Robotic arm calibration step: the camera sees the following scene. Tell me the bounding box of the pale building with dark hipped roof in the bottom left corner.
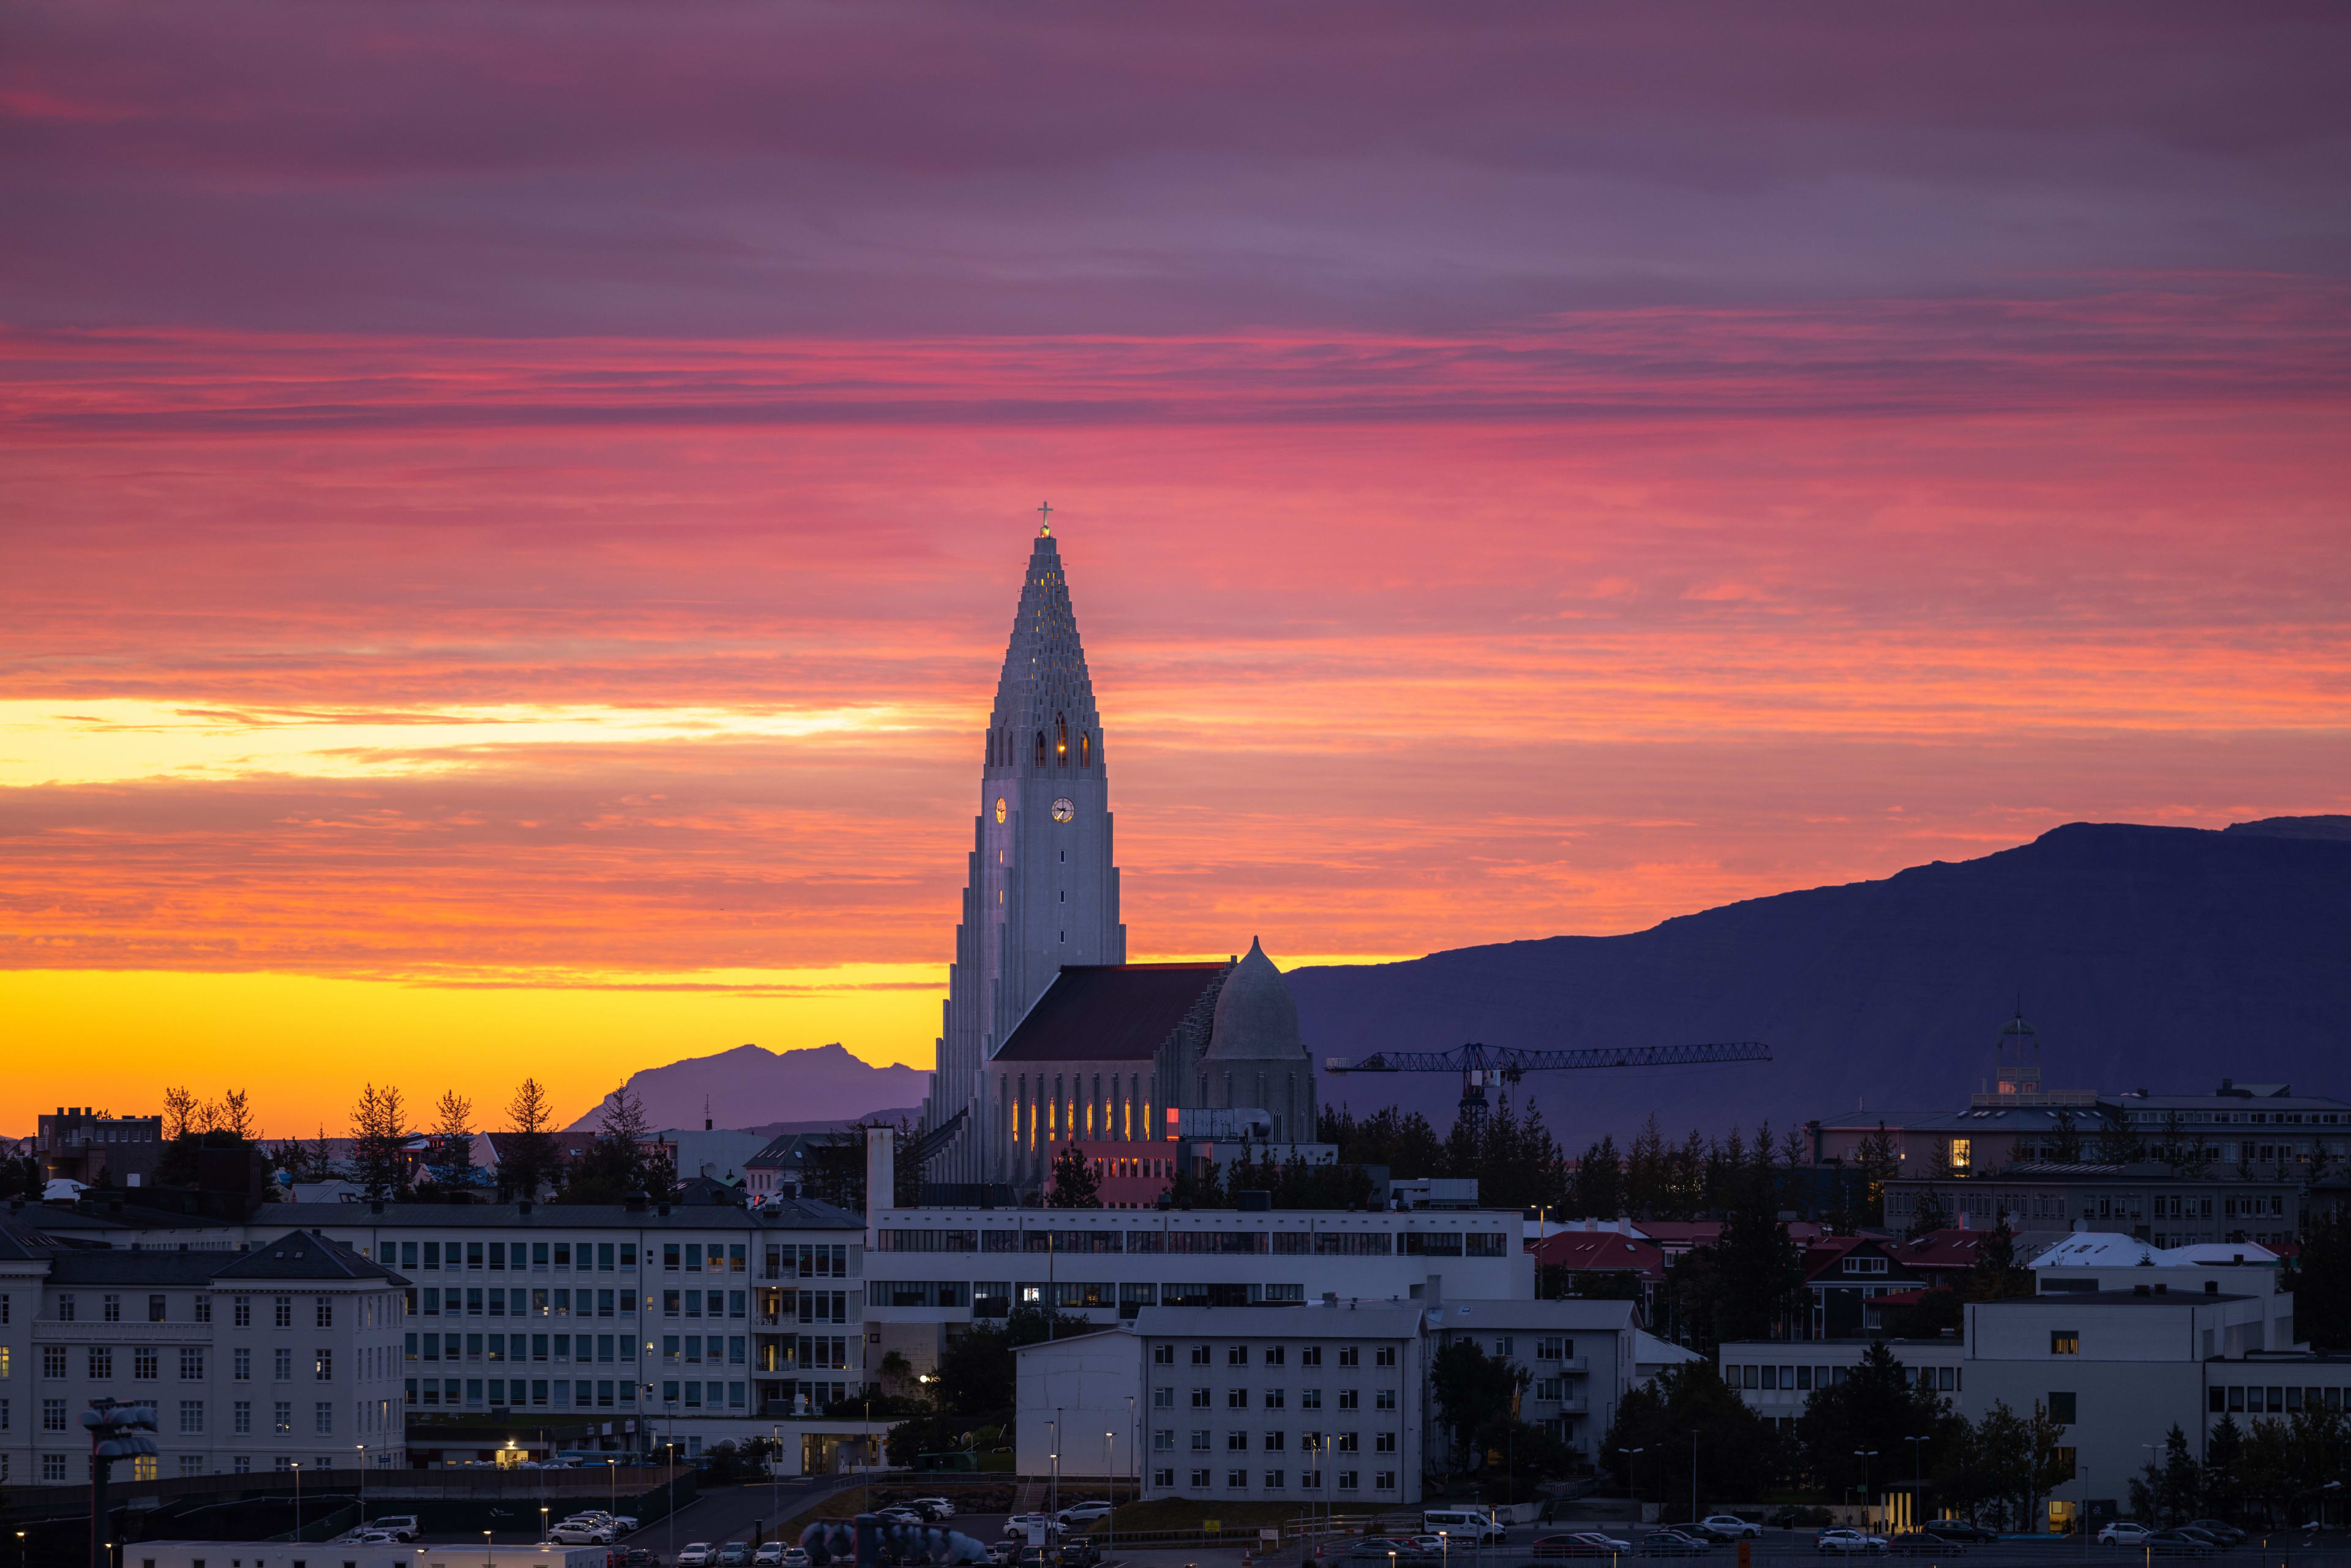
[0,1215,407,1486]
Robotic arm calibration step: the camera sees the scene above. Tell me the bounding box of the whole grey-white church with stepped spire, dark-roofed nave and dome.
[921,527,1316,1201]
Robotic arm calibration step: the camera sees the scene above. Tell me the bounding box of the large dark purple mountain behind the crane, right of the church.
[1291,816,2351,1154]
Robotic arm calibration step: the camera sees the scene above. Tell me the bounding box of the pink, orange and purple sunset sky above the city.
[0,0,2351,1133]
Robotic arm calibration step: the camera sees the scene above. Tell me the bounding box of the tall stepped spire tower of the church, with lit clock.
[921,524,1126,1182]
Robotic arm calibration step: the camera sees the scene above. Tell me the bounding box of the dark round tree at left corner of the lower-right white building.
[1601,1361,1785,1521]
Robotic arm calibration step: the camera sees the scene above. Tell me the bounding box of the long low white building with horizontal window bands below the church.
[863,1213,1535,1373]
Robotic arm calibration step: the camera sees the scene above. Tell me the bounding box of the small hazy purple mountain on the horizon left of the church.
[571,1044,931,1131]
